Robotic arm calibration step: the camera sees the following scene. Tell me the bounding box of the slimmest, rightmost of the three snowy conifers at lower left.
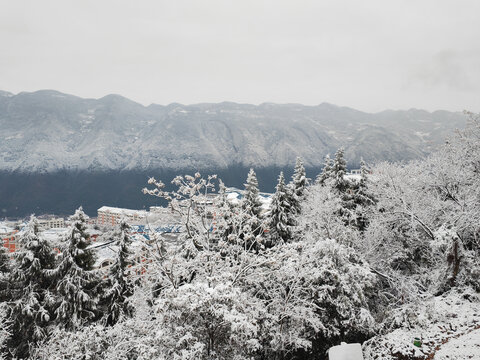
[105,219,134,325]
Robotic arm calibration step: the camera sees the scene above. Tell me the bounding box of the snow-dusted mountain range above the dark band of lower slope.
[0,90,465,173]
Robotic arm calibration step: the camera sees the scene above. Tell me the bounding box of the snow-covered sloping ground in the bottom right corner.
[363,291,480,360]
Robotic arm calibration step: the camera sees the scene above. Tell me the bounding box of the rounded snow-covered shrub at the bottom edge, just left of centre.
[155,281,262,359]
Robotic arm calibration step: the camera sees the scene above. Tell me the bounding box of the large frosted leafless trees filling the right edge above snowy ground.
[360,117,480,302]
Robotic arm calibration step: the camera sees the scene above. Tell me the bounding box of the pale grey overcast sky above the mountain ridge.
[0,0,480,112]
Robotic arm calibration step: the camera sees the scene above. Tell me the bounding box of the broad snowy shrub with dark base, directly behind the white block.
[242,239,377,358]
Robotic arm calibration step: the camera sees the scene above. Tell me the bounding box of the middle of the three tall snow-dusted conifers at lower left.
[52,207,101,329]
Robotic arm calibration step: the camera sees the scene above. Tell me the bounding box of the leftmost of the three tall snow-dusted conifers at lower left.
[8,216,56,359]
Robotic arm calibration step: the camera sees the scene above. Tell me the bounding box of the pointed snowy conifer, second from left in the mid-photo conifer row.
[268,172,295,245]
